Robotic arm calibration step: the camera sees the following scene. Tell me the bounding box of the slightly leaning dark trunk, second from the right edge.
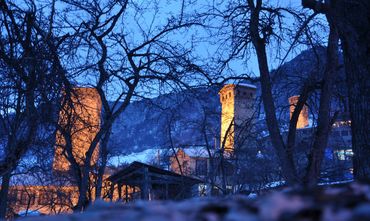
[305,25,339,186]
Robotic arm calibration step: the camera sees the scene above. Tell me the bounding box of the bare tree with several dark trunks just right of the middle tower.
[205,0,338,185]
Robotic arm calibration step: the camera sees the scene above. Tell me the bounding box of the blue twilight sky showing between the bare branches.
[28,0,327,99]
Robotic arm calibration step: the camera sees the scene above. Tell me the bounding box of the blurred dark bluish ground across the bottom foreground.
[24,183,370,221]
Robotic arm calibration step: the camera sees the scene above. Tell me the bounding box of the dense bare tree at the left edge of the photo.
[0,1,66,218]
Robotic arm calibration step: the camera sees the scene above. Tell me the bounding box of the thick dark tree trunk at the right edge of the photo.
[302,0,370,180]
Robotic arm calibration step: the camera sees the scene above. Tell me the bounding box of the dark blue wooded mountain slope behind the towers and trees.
[109,47,345,153]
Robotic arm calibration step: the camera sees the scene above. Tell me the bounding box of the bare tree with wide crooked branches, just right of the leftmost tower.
[48,0,211,210]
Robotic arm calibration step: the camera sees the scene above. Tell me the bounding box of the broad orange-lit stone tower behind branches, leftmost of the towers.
[53,88,102,171]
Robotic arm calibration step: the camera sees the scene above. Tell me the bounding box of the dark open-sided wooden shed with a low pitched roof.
[107,161,203,202]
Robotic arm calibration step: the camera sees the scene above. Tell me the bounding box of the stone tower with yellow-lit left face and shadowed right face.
[219,84,257,152]
